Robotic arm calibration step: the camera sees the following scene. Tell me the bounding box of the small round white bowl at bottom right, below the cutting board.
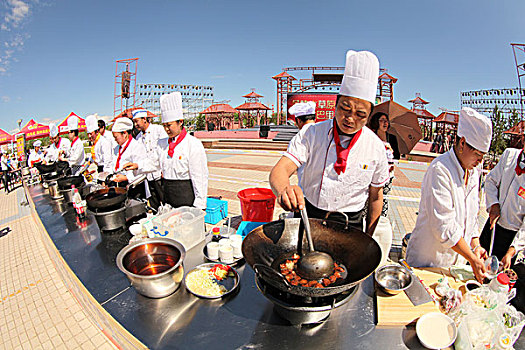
[416,312,458,349]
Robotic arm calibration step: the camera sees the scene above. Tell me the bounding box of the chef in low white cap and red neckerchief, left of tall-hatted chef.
[108,117,155,198]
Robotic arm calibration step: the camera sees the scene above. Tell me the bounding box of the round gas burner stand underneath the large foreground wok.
[255,275,358,325]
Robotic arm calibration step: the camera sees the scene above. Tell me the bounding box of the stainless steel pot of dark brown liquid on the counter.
[117,238,186,298]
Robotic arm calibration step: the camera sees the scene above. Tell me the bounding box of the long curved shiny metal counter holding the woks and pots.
[27,185,492,349]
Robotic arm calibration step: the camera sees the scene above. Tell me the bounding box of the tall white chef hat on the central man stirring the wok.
[339,50,379,104]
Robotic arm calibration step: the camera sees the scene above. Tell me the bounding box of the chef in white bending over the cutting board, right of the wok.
[407,108,492,281]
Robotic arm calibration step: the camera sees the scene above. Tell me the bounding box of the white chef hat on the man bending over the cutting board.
[458,107,492,152]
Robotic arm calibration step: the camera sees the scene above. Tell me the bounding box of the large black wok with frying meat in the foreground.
[242,219,381,297]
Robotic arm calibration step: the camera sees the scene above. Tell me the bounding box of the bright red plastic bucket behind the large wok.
[237,188,276,222]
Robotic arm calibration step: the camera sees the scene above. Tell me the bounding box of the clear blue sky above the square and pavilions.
[0,0,525,132]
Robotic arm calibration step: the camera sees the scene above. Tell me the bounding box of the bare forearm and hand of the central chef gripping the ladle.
[270,156,304,211]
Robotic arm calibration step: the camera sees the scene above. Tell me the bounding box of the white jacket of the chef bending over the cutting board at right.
[407,149,480,267]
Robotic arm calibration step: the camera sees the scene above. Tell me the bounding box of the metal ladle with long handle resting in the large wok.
[297,208,334,280]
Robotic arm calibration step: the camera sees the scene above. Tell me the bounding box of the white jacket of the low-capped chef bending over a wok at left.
[104,138,156,183]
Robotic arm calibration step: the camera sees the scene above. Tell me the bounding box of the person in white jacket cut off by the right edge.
[480,141,525,268]
